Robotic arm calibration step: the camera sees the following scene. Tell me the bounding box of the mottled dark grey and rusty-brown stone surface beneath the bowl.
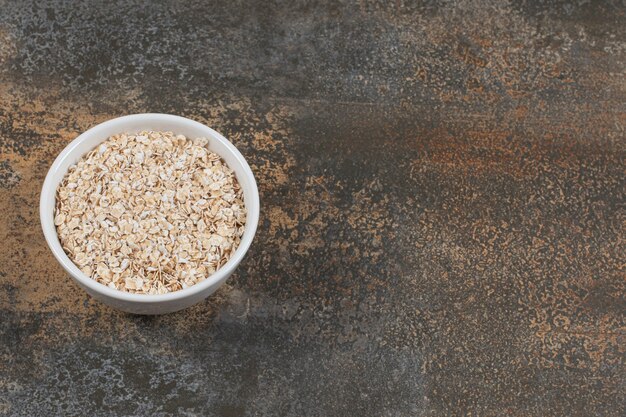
[0,0,626,417]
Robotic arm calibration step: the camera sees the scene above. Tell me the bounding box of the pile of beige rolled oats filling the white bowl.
[54,131,246,294]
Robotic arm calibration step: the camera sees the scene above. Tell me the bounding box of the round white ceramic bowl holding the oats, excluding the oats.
[39,114,259,314]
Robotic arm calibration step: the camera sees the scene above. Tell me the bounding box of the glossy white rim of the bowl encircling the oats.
[39,113,260,303]
